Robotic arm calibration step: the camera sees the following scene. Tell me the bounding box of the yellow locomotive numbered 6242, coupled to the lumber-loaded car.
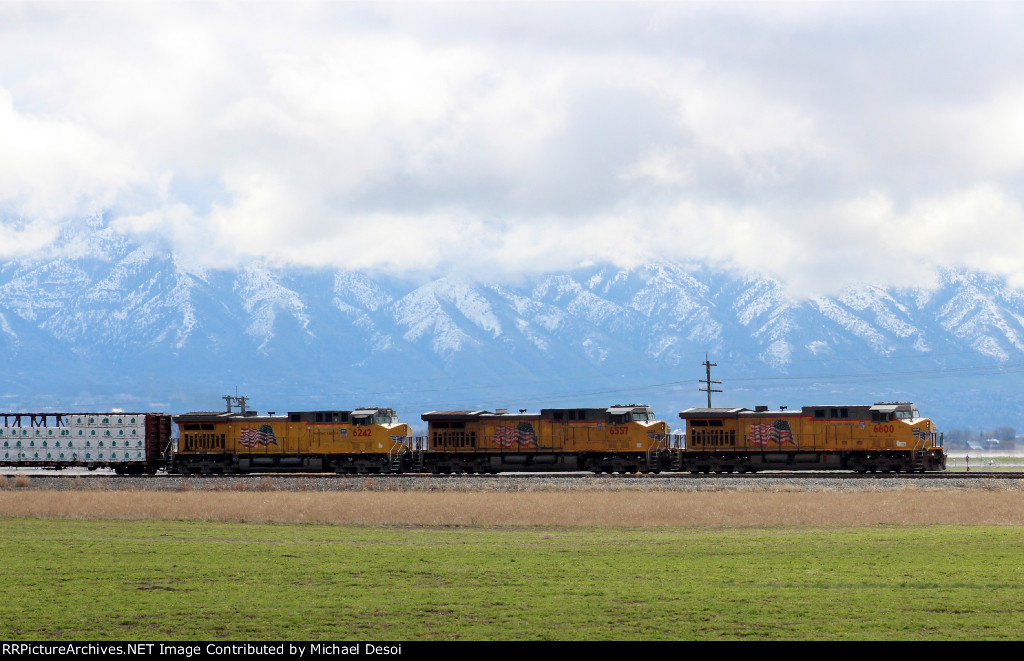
[171,397,413,473]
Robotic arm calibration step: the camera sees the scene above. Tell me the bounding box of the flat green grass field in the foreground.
[0,519,1024,641]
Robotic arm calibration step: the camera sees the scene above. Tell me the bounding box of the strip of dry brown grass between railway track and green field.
[0,489,1024,526]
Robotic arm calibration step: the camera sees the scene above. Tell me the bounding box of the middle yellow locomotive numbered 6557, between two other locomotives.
[412,404,671,473]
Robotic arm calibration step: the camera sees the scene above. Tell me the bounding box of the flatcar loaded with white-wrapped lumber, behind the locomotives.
[0,411,172,475]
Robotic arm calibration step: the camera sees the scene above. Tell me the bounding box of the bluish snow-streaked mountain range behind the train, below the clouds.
[0,228,1024,429]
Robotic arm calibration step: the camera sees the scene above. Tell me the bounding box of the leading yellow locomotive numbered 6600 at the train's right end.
[679,402,946,473]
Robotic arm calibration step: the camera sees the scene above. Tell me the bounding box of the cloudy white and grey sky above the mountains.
[0,0,1024,295]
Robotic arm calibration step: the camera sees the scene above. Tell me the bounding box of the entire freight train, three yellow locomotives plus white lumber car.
[0,397,946,474]
